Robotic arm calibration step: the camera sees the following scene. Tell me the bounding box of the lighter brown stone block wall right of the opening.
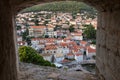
[96,10,120,80]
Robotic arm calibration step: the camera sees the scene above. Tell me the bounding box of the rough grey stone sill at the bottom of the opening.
[19,63,97,80]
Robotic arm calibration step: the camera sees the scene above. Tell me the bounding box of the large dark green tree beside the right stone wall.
[83,24,96,39]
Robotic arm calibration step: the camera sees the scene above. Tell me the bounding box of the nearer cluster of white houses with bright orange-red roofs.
[31,38,96,63]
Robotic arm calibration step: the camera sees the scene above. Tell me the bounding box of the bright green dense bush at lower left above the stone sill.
[19,46,55,67]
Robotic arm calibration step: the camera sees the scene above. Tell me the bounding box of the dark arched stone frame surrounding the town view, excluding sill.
[0,0,120,80]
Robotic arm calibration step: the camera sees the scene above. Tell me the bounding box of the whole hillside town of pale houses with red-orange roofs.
[16,11,97,63]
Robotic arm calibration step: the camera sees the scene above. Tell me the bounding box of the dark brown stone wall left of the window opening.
[0,0,17,80]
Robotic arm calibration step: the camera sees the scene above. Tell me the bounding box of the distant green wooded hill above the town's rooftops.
[21,1,96,13]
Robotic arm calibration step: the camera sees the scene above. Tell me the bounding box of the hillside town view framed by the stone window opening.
[16,1,97,80]
